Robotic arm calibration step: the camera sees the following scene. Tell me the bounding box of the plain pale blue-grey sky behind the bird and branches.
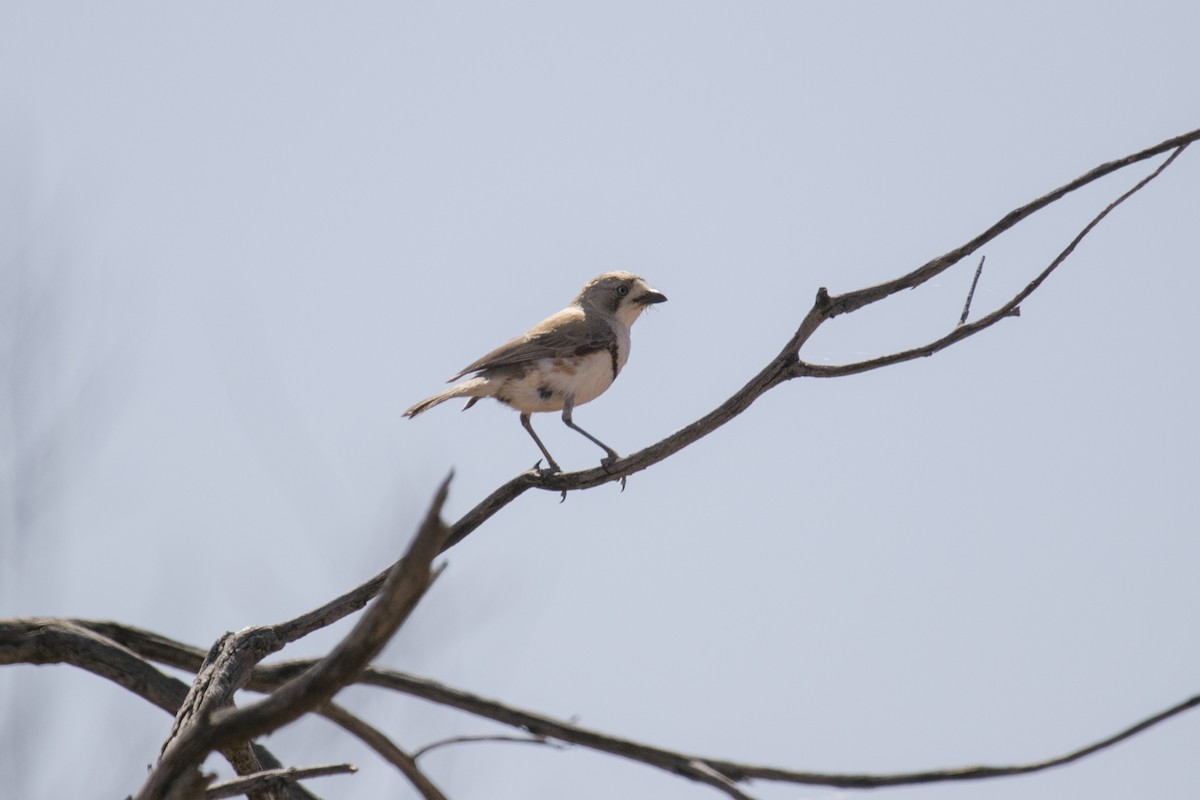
[0,1,1200,800]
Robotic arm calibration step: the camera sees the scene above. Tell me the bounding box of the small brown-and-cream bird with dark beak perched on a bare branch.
[404,272,666,474]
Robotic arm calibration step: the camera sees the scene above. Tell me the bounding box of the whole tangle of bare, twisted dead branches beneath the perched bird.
[0,130,1200,800]
